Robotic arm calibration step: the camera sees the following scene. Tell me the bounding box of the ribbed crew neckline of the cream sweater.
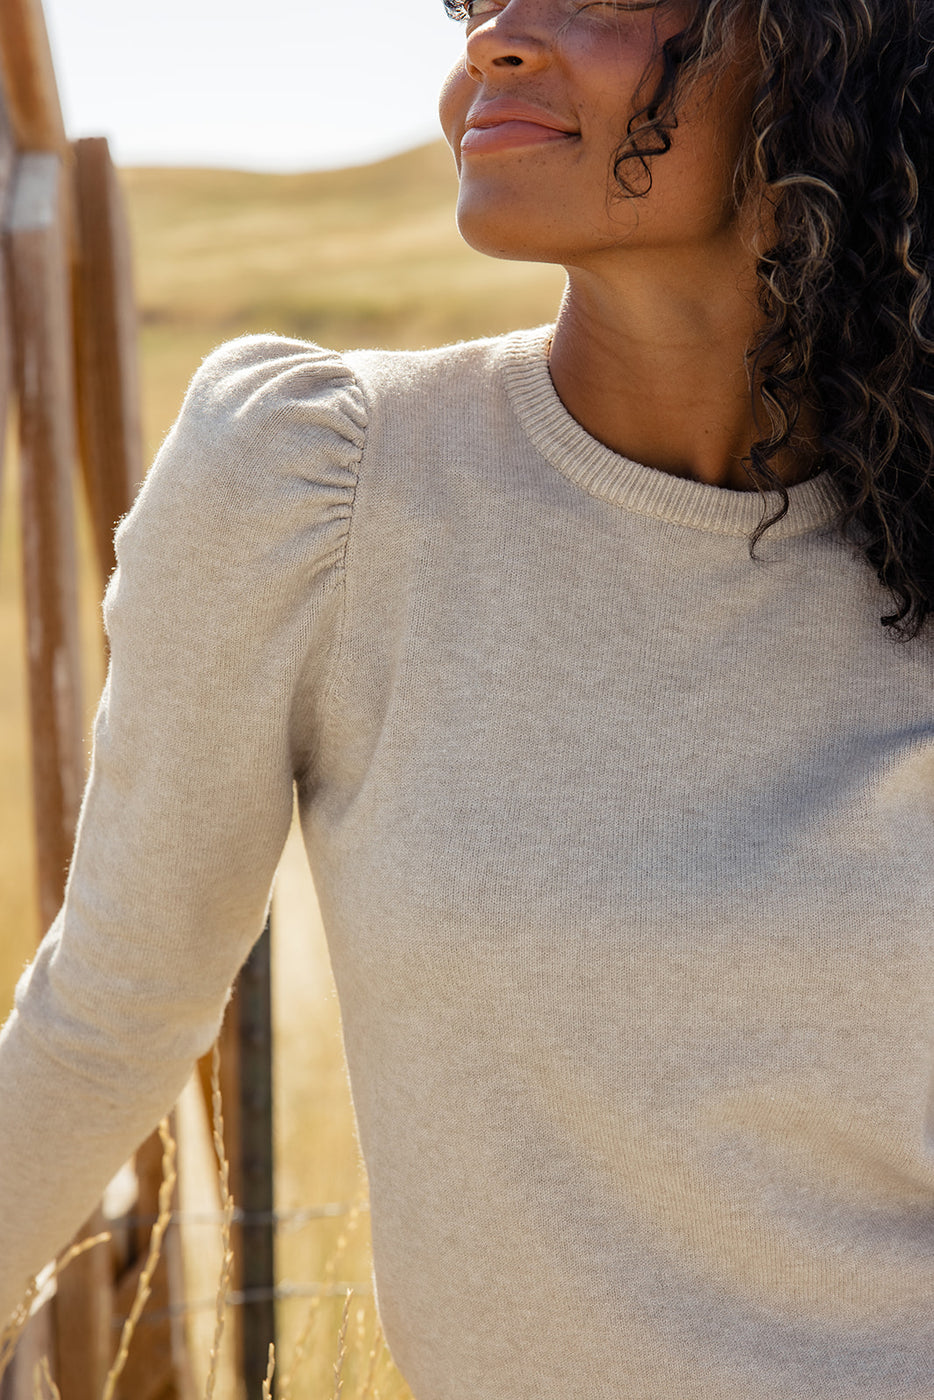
[503,326,840,538]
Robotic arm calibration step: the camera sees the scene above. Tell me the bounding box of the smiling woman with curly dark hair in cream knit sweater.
[0,0,934,1400]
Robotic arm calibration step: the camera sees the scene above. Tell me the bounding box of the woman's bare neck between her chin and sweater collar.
[550,251,808,490]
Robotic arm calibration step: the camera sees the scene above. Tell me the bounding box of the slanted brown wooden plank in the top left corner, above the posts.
[0,0,67,155]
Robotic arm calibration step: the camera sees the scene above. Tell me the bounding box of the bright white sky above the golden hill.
[43,0,462,171]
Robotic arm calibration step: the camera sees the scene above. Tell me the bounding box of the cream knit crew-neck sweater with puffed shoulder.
[0,332,934,1400]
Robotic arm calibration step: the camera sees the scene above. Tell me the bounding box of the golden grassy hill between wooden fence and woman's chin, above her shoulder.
[122,141,564,445]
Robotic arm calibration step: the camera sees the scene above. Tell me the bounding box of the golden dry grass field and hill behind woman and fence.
[0,144,563,1400]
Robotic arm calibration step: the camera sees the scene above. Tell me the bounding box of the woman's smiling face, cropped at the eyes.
[440,0,748,266]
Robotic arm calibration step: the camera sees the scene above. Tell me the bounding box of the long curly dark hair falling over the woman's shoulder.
[444,0,934,640]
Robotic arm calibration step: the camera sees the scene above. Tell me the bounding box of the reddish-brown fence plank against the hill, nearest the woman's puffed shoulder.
[73,137,143,581]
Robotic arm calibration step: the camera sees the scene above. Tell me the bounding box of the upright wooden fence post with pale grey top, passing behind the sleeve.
[0,147,111,1400]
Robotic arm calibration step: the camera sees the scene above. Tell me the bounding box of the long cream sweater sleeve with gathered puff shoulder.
[0,336,365,1323]
